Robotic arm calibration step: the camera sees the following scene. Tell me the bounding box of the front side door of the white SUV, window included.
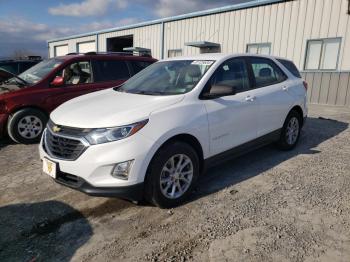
[203,57,258,156]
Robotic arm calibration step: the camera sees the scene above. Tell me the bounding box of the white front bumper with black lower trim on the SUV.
[39,132,156,201]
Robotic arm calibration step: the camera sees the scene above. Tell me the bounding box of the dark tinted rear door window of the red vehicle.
[92,60,130,82]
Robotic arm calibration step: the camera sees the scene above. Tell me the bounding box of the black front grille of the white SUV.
[44,128,88,160]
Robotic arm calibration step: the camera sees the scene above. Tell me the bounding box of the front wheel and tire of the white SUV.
[145,142,199,208]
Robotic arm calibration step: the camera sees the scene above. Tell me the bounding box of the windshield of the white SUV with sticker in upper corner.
[117,60,214,95]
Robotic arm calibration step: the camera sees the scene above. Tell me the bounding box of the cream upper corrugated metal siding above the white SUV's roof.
[160,0,350,70]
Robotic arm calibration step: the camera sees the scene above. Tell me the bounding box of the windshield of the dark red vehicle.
[18,58,63,85]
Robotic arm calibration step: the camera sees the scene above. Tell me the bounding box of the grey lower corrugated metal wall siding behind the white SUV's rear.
[302,72,350,106]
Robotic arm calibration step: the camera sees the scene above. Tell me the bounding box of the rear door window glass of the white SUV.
[249,57,287,87]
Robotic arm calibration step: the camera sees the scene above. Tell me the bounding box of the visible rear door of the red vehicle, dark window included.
[92,59,131,90]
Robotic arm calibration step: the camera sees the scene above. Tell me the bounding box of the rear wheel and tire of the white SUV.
[277,110,302,150]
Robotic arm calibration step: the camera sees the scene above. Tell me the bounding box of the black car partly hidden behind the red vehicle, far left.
[0,56,42,83]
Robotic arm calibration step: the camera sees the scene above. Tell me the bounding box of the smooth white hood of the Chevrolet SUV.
[50,89,184,128]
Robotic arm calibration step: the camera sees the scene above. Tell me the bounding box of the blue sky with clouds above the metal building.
[0,0,249,57]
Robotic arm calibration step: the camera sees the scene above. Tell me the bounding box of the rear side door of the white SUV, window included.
[248,57,293,137]
